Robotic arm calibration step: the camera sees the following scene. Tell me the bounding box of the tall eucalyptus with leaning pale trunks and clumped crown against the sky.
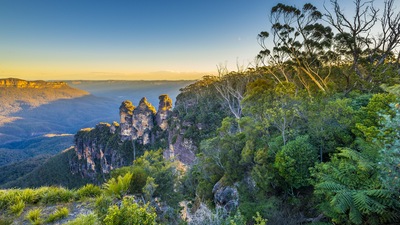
[258,3,333,95]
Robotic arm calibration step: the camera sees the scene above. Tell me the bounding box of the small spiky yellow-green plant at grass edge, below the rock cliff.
[103,173,132,199]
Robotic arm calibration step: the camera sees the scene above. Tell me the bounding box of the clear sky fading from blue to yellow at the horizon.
[0,0,396,80]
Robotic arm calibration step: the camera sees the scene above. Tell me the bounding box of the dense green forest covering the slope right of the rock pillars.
[0,0,400,225]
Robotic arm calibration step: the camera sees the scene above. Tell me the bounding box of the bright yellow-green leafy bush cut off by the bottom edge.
[103,198,157,225]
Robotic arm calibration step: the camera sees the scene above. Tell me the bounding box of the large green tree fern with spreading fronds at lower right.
[315,149,399,224]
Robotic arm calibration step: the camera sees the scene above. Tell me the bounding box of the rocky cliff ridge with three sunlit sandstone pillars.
[70,95,196,183]
